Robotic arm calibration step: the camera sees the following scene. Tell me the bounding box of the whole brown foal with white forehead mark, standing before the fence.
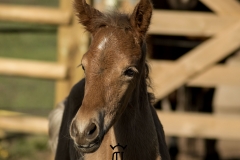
[50,0,170,160]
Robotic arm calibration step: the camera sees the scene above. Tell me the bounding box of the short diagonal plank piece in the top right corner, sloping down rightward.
[200,0,240,17]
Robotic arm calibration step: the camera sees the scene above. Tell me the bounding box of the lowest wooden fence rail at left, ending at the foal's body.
[0,111,48,135]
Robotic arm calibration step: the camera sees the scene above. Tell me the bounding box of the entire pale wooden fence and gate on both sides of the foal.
[0,0,240,144]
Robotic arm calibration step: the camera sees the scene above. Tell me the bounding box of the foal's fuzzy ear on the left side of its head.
[74,0,103,33]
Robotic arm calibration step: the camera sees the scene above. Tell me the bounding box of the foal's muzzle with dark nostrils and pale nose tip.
[70,119,102,153]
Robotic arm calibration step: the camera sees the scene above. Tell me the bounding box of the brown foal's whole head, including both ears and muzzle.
[70,0,152,153]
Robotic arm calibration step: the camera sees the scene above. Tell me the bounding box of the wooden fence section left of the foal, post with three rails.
[0,0,88,134]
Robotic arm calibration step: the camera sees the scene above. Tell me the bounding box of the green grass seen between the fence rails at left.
[0,0,58,160]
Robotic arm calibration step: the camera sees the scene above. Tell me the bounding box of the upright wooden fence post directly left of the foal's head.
[55,0,89,104]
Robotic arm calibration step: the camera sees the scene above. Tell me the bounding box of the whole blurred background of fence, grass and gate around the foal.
[0,0,240,160]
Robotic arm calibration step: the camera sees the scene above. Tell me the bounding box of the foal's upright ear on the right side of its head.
[130,0,153,36]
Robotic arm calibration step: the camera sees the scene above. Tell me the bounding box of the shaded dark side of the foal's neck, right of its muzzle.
[111,76,158,160]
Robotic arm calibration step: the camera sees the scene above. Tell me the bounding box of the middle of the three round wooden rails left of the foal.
[0,58,67,79]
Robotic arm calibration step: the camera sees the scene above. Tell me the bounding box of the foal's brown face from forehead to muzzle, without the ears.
[71,27,142,152]
